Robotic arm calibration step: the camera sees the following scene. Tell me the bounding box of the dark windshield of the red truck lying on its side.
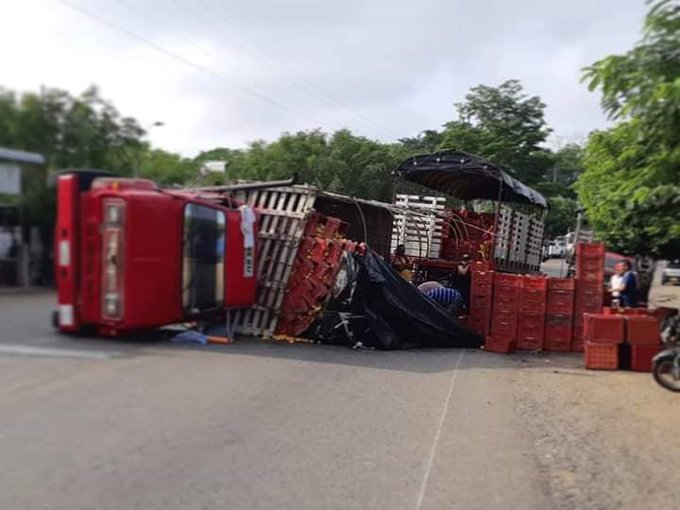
[182,203,226,315]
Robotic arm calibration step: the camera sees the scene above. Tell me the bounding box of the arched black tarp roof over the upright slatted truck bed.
[393,150,547,209]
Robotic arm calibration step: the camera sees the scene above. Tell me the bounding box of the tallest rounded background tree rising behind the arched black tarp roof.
[441,80,552,184]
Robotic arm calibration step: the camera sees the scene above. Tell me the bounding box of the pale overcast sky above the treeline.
[0,0,645,156]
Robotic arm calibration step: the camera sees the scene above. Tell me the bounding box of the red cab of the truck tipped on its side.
[55,172,256,335]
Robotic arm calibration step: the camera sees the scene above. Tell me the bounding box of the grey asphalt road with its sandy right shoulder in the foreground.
[0,294,680,510]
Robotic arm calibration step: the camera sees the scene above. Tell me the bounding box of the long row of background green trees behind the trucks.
[0,80,581,241]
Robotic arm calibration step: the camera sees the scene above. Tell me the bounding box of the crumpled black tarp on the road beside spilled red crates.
[305,250,483,350]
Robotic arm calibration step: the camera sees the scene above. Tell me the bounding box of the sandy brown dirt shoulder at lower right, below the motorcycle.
[515,354,680,510]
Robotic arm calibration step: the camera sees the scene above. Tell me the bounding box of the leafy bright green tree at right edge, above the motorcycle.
[577,0,680,257]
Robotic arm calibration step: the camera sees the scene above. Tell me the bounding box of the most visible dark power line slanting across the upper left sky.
[59,0,323,126]
